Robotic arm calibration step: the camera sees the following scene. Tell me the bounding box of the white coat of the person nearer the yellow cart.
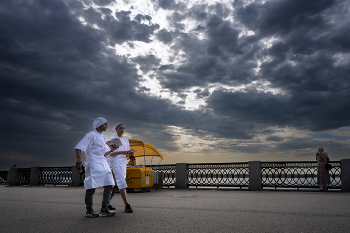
[107,135,130,189]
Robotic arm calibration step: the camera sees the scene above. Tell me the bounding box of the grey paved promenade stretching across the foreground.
[0,185,350,233]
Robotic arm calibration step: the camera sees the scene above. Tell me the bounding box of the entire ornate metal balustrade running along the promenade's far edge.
[0,159,350,190]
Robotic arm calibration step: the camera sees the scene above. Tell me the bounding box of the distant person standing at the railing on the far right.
[316,147,331,191]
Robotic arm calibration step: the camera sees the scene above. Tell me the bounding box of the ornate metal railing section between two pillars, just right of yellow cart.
[187,163,249,188]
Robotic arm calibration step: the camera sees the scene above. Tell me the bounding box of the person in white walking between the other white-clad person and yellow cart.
[107,123,134,213]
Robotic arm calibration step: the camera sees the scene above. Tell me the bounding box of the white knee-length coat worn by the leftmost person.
[75,130,115,189]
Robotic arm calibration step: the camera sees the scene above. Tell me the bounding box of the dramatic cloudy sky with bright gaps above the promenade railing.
[0,0,350,170]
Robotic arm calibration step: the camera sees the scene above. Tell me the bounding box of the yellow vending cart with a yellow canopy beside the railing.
[126,139,163,191]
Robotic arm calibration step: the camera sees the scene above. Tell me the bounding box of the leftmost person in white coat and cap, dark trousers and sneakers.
[75,117,117,218]
